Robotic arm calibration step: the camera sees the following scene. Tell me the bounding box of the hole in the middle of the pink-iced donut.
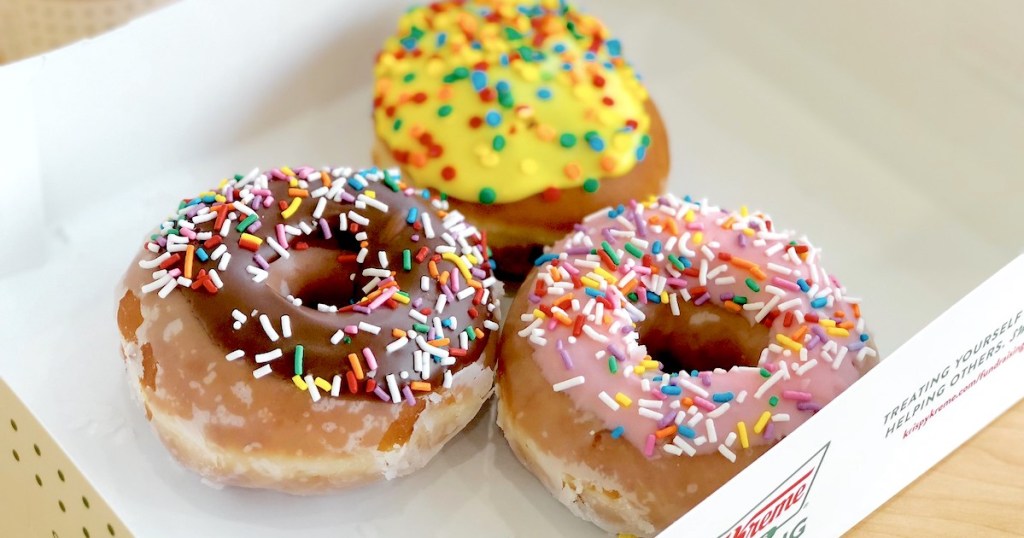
[638,303,768,373]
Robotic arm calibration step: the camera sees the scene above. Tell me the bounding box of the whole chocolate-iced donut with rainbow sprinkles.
[117,167,502,494]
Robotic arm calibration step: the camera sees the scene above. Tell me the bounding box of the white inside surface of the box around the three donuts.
[0,0,1024,537]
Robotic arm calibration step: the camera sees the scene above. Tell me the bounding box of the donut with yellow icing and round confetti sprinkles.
[373,0,669,282]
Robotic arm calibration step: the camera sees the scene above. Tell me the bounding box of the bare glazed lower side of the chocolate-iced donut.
[119,282,497,495]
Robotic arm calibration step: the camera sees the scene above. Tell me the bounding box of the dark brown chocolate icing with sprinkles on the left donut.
[137,169,498,399]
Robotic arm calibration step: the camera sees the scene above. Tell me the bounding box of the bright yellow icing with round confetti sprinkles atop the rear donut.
[374,0,650,203]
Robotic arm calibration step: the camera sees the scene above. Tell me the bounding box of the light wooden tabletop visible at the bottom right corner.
[848,401,1024,538]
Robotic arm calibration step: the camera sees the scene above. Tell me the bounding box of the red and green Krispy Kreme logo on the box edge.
[719,443,828,538]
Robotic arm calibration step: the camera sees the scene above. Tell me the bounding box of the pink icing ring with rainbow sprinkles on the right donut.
[519,195,877,459]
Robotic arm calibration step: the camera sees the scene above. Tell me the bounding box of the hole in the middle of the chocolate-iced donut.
[265,248,362,308]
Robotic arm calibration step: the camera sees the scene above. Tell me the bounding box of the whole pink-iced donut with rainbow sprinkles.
[497,195,878,536]
